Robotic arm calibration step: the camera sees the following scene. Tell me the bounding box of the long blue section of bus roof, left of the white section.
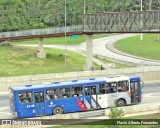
[10,78,106,91]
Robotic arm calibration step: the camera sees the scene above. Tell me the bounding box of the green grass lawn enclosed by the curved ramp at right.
[115,34,160,60]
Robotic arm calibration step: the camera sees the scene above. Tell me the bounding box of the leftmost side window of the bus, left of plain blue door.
[18,92,32,103]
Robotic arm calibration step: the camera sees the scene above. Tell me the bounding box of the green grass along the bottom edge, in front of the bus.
[50,114,160,128]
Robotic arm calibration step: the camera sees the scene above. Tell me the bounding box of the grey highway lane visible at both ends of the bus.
[0,83,160,119]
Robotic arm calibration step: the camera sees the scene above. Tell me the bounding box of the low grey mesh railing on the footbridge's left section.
[0,25,83,38]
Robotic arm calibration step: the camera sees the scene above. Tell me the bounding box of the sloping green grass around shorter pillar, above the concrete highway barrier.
[0,46,99,77]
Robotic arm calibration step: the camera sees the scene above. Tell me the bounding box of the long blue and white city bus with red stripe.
[9,75,142,118]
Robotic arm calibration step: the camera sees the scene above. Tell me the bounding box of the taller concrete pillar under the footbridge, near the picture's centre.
[83,35,93,71]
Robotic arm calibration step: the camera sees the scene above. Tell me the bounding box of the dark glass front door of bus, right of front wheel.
[130,81,139,104]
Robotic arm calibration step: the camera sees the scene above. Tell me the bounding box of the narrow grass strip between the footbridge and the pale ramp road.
[11,34,113,45]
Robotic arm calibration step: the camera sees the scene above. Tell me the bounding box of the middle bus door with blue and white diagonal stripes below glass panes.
[84,86,99,109]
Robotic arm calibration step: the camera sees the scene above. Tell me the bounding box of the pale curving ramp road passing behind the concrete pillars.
[21,34,160,66]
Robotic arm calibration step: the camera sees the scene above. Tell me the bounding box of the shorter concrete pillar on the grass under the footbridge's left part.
[36,38,46,58]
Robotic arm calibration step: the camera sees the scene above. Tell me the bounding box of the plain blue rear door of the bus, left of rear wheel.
[34,91,45,116]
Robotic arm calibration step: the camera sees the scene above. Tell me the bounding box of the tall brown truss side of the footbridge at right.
[84,11,160,33]
